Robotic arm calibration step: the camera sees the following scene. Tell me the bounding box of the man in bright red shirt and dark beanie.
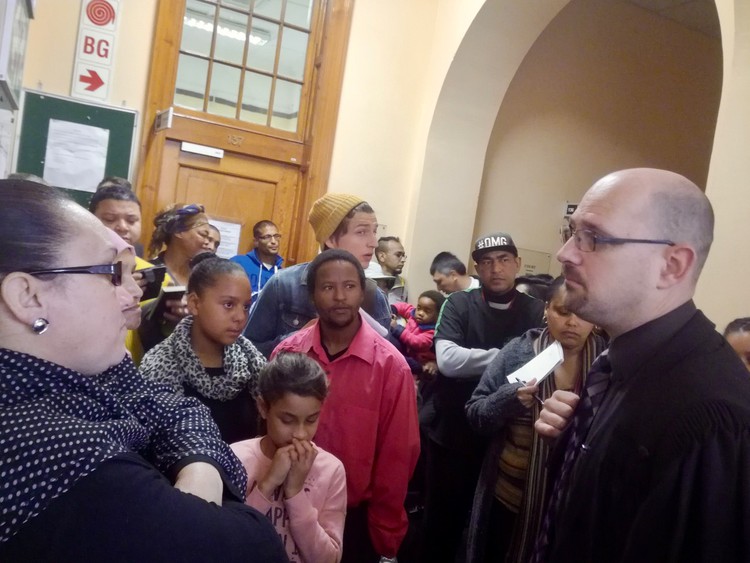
[274,250,419,563]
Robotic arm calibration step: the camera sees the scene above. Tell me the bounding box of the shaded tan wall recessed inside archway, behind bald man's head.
[474,0,722,275]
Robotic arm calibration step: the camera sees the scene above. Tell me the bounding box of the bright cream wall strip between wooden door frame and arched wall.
[329,0,435,236]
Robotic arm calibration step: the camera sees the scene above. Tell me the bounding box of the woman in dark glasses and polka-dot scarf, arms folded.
[0,181,286,562]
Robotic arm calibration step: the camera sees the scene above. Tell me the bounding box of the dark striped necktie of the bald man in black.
[531,350,612,563]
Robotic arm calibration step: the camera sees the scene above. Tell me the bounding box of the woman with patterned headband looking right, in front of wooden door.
[138,203,214,353]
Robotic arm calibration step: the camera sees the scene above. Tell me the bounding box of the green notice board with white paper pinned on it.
[16,91,136,207]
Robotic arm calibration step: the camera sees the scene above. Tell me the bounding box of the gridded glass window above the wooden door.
[174,0,317,132]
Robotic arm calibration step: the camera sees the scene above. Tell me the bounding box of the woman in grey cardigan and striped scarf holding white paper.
[466,277,604,563]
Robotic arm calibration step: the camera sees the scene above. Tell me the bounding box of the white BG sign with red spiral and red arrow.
[71,0,121,100]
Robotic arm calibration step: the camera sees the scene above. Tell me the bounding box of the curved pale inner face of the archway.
[406,0,568,295]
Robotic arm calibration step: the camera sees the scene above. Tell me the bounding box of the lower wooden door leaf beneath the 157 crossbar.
[144,140,306,265]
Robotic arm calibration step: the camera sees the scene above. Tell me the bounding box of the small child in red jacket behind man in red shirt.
[391,290,445,375]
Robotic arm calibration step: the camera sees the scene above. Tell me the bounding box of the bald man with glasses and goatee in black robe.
[532,169,750,562]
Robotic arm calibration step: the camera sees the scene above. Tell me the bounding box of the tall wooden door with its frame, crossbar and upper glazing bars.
[137,0,353,265]
